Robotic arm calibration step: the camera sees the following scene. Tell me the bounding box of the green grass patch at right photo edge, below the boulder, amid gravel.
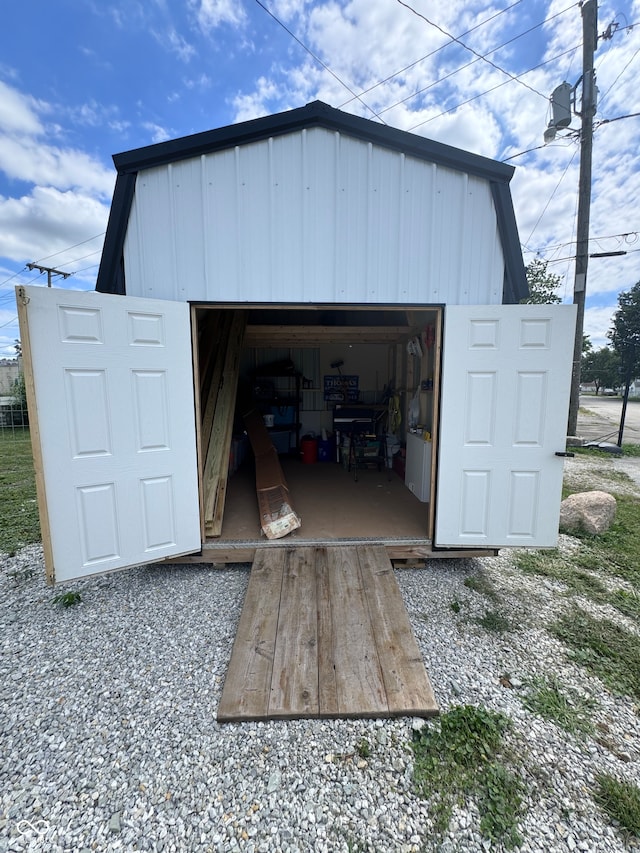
[550,609,640,699]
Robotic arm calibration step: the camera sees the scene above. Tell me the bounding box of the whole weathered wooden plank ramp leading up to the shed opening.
[218,546,438,722]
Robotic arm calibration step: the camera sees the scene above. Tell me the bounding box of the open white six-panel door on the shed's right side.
[434,305,575,548]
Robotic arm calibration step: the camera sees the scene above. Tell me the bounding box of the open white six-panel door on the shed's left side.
[18,287,201,581]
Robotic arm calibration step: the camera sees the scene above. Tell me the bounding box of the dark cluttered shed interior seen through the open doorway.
[192,304,442,562]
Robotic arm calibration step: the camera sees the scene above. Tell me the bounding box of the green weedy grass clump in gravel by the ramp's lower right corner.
[413,705,524,848]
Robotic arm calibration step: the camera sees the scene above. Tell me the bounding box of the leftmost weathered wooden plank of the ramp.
[218,549,285,722]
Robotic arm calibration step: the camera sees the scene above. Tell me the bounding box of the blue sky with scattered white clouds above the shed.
[0,0,640,357]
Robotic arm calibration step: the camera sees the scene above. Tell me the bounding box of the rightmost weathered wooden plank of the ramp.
[356,546,438,716]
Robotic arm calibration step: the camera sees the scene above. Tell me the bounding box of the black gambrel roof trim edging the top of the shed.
[96,101,528,303]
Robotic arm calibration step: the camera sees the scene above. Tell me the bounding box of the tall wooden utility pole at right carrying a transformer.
[567,0,598,435]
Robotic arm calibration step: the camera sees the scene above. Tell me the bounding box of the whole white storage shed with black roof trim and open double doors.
[18,102,575,581]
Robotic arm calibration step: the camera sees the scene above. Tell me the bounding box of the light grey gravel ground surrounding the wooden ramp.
[0,460,640,853]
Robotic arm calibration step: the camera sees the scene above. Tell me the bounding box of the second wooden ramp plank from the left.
[269,548,319,719]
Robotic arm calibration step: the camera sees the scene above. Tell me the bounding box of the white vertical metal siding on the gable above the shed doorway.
[125,123,504,304]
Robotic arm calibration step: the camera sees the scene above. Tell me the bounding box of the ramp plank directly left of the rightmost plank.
[321,548,388,716]
